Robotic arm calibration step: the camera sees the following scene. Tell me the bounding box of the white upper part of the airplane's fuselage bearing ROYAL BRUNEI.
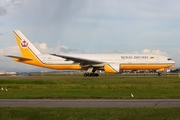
[38,54,175,64]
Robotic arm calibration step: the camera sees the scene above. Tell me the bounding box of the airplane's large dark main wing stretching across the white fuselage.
[51,54,103,65]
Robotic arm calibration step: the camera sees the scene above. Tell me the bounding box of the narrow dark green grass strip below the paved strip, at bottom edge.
[0,108,180,120]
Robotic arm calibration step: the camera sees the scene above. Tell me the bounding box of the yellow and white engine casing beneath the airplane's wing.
[104,63,120,73]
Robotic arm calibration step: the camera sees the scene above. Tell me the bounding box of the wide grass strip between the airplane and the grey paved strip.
[0,75,180,99]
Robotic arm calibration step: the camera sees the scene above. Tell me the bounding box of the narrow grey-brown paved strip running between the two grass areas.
[0,99,180,108]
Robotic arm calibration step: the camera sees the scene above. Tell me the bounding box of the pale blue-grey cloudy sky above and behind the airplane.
[0,0,180,71]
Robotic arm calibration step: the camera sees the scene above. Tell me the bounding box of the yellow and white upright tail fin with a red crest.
[14,30,41,58]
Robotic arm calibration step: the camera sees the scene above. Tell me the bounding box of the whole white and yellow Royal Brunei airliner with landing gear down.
[7,30,175,77]
